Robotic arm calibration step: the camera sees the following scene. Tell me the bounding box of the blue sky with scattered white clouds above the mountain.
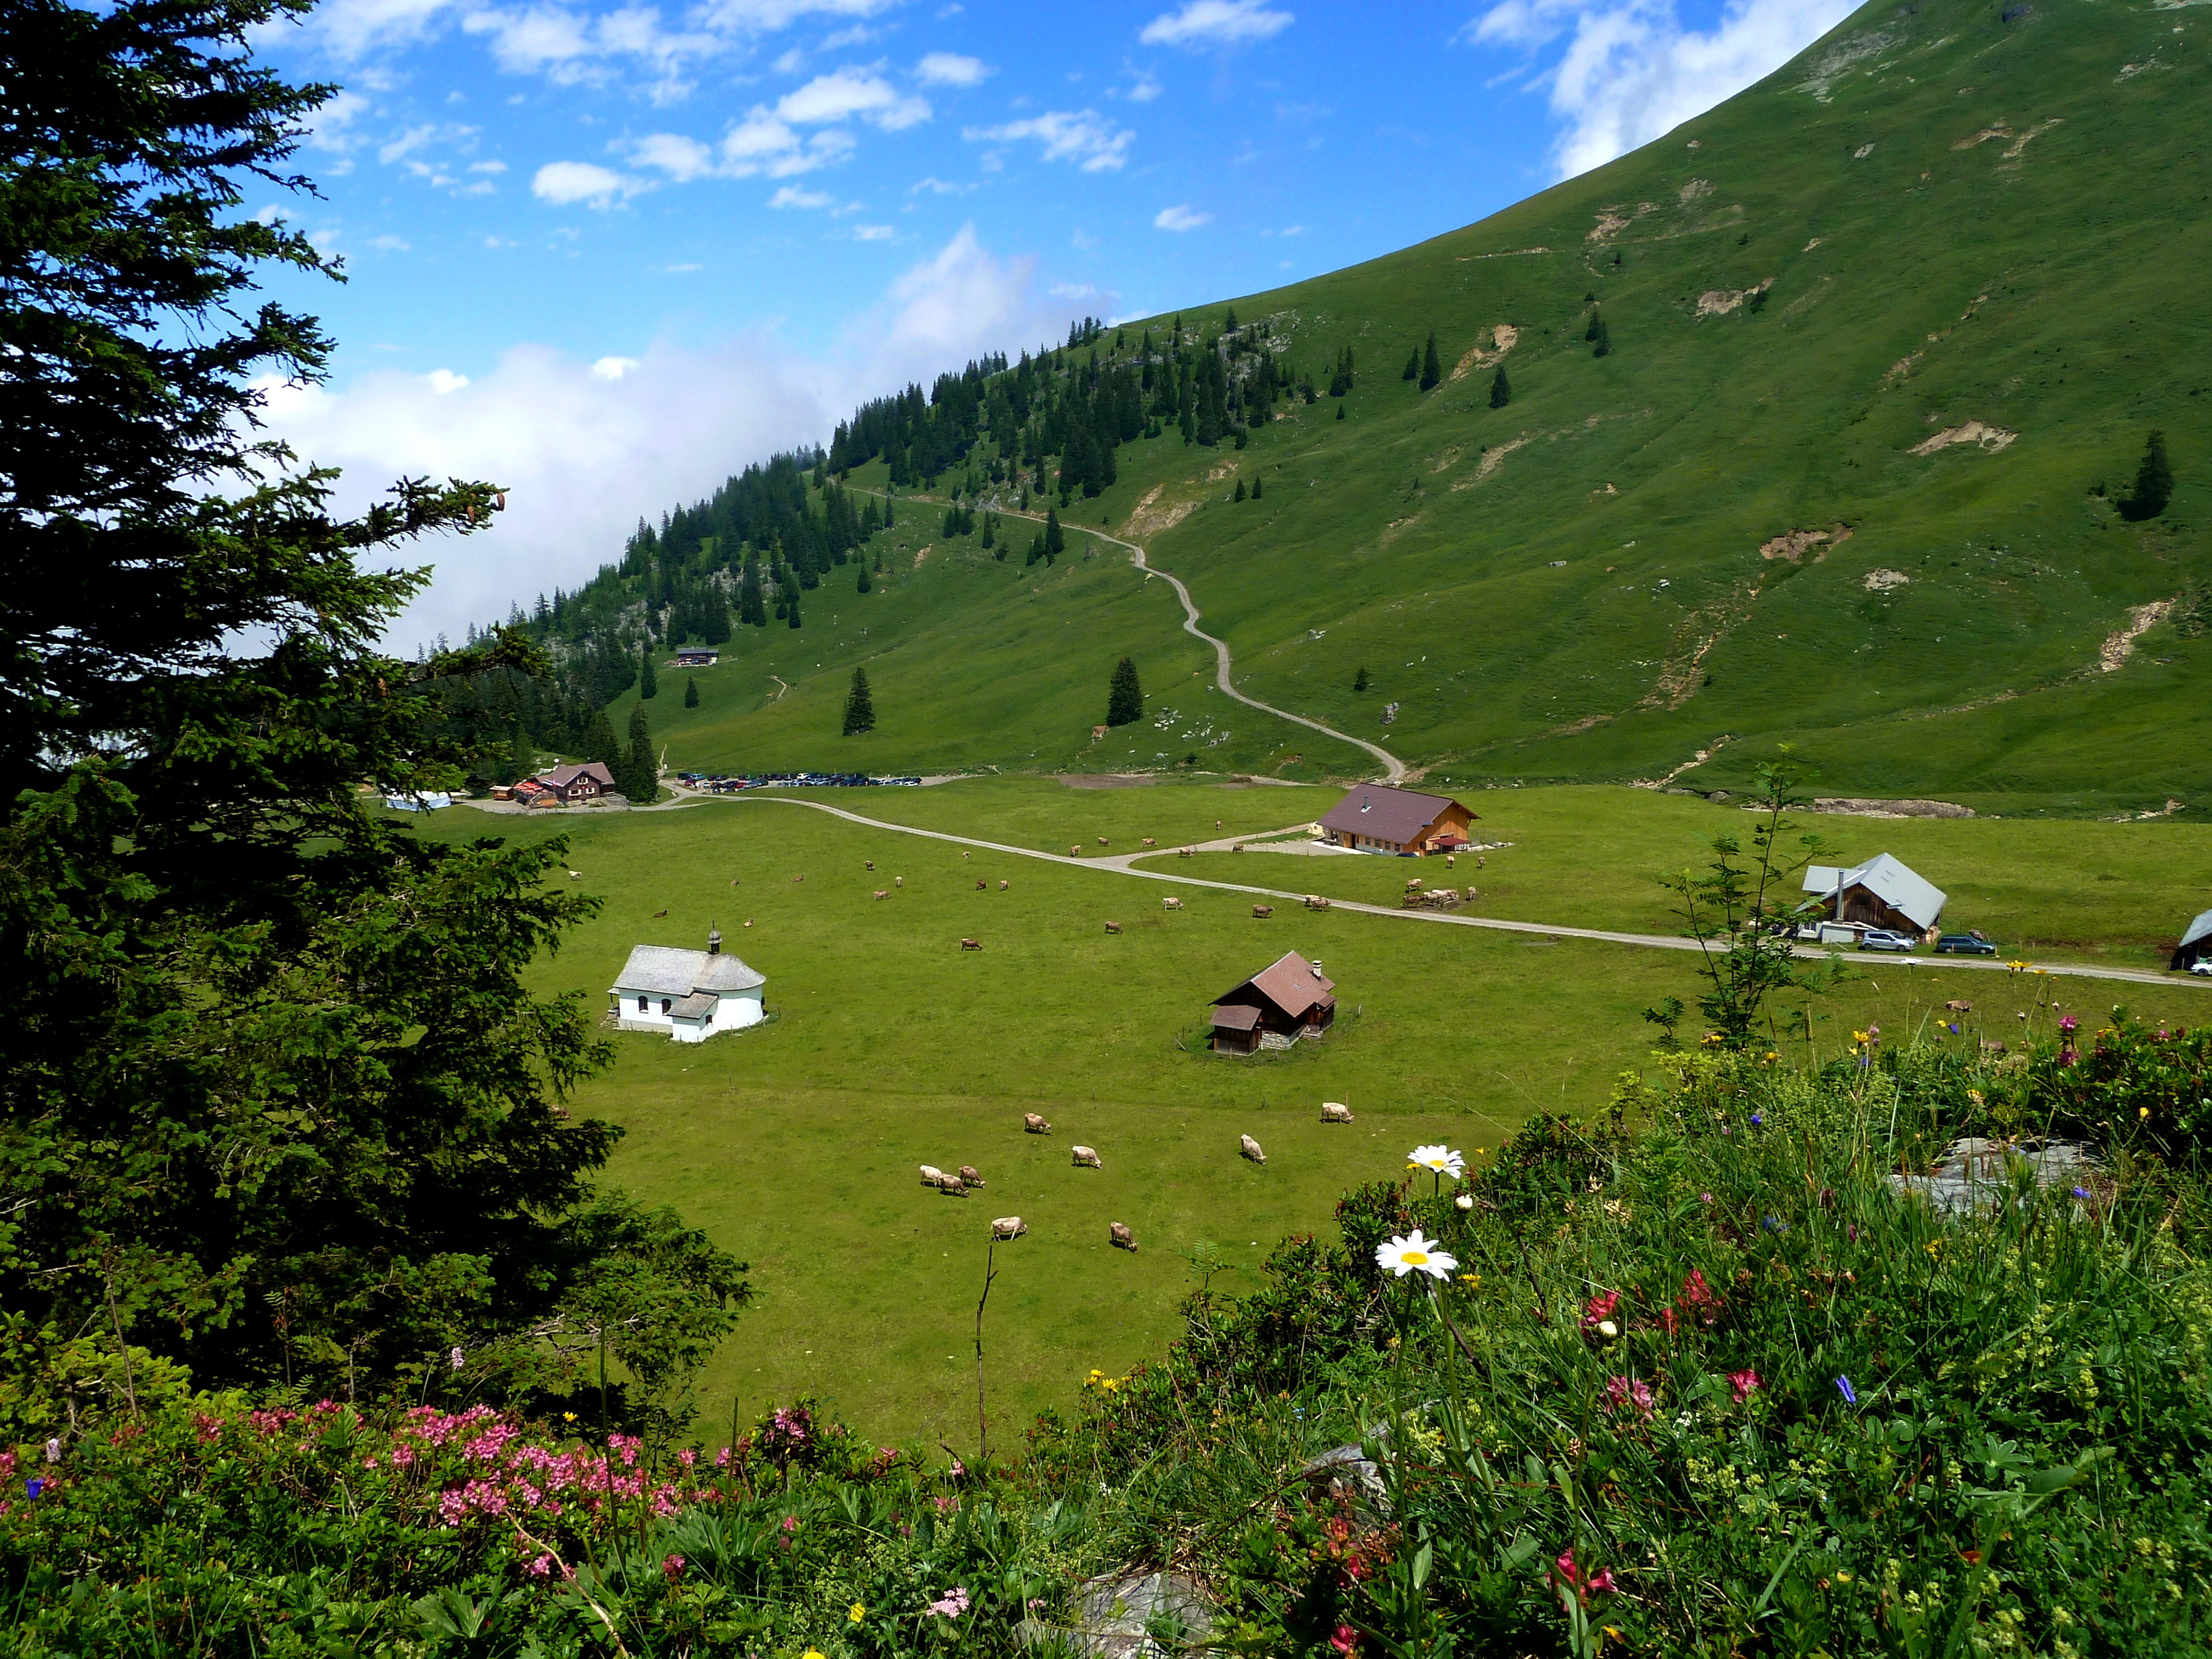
[250,0,1850,644]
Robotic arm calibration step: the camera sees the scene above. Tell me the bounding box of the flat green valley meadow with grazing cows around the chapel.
[402,778,2212,1445]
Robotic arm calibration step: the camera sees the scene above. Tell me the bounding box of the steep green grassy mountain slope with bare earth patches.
[588,0,2212,807]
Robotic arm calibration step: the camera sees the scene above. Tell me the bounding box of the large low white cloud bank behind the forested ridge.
[265,230,1077,650]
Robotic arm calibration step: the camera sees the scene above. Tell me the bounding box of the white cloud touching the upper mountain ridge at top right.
[1460,0,1854,177]
